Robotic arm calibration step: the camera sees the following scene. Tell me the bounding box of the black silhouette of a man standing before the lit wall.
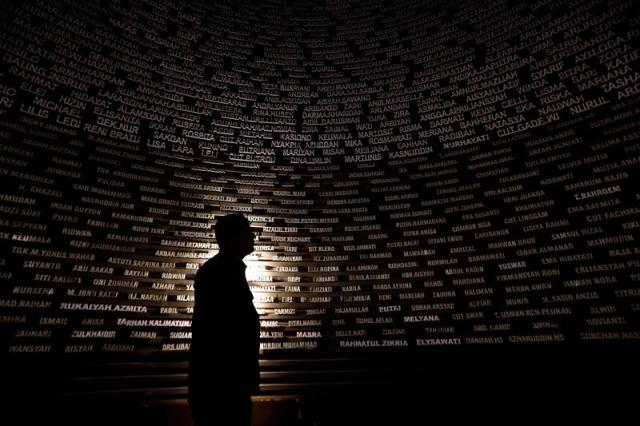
[189,214,260,426]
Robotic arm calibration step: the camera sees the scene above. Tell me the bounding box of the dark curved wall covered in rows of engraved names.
[0,0,640,398]
